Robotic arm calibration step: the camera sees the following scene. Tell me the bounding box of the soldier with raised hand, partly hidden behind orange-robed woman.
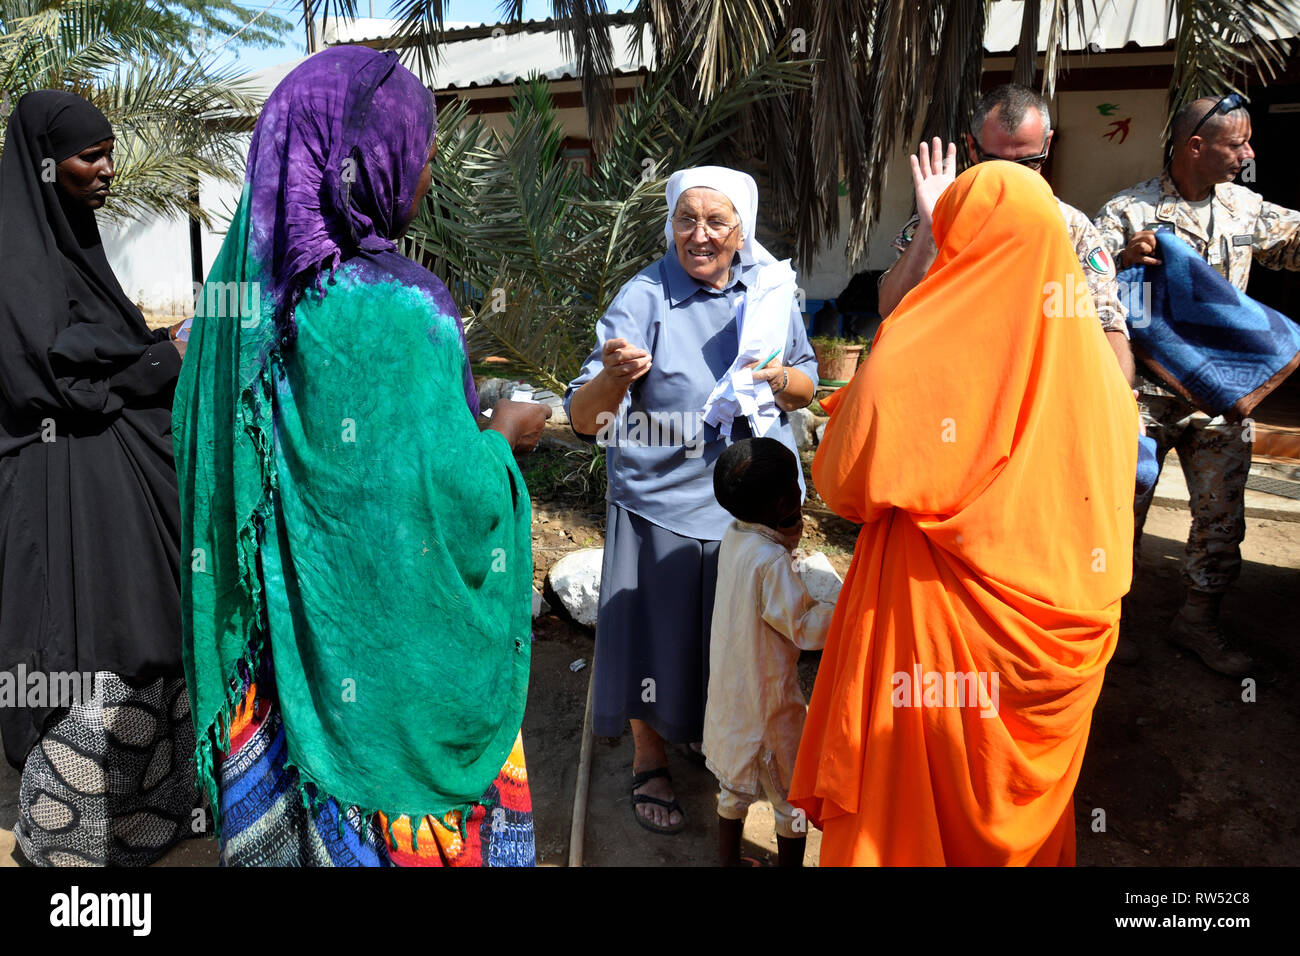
[879,83,1134,382]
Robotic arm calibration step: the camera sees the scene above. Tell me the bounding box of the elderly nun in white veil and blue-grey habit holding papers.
[564,166,816,834]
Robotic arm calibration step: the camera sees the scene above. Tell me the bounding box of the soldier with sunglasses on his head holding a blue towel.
[1096,94,1300,676]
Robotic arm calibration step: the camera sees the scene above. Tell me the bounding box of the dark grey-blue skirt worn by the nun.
[592,503,722,743]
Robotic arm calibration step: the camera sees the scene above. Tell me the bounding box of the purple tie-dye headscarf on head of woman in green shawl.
[246,47,437,325]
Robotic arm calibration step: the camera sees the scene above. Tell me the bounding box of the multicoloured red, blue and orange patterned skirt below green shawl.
[217,658,537,866]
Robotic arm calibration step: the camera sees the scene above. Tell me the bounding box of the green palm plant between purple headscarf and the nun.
[407,51,809,388]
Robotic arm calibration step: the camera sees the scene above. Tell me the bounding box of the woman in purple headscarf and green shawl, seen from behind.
[176,47,547,865]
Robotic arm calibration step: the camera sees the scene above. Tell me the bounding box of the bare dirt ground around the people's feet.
[0,447,1300,866]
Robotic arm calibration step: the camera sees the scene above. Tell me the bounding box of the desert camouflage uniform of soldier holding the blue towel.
[1096,170,1300,594]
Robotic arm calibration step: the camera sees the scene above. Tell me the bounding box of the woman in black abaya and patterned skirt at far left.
[0,90,196,865]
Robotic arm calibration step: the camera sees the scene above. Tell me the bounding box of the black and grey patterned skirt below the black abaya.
[14,671,203,866]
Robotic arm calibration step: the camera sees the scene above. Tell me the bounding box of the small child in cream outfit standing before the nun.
[703,438,835,866]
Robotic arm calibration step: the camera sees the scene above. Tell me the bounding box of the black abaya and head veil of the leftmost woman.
[0,91,181,767]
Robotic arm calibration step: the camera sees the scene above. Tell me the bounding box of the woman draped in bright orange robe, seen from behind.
[790,161,1138,866]
